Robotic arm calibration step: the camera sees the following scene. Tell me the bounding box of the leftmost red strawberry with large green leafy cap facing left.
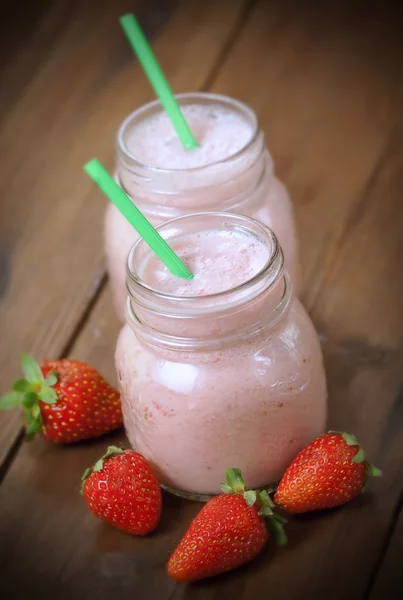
[0,354,122,444]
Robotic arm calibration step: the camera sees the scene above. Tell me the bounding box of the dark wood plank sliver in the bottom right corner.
[370,510,403,600]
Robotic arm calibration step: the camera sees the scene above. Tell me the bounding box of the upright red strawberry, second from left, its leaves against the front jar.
[82,446,162,535]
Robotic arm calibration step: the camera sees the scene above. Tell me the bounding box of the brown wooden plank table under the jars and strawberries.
[0,0,403,600]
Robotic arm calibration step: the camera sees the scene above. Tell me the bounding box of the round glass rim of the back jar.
[116,92,260,174]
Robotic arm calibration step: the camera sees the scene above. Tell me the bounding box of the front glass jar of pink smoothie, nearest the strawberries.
[116,213,326,499]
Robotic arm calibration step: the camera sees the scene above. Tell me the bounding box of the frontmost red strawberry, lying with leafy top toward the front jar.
[167,469,287,581]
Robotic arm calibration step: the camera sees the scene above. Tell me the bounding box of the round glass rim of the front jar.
[126,212,284,312]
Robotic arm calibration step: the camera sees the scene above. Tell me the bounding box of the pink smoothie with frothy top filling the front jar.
[116,216,326,495]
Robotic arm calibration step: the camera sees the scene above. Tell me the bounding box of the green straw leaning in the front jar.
[84,158,194,279]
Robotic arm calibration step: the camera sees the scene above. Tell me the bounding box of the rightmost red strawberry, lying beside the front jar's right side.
[274,431,382,513]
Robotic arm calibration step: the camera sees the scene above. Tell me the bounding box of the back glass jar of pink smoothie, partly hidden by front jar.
[104,92,300,321]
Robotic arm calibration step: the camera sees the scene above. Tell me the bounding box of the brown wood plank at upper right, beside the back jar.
[213,0,402,307]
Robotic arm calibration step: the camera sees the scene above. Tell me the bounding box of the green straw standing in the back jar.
[119,13,199,150]
